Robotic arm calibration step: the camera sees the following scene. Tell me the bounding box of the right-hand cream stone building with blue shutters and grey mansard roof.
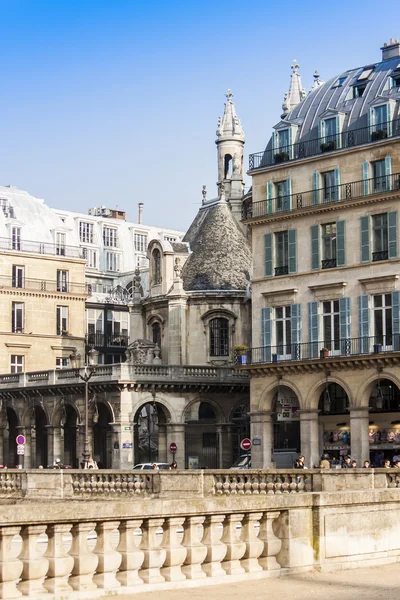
[241,40,400,467]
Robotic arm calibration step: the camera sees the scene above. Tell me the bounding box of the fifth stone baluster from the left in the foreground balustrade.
[93,521,122,590]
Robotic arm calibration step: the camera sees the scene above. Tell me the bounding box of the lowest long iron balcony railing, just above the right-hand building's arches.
[235,333,400,365]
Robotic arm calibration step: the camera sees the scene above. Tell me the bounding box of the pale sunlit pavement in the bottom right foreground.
[119,564,400,600]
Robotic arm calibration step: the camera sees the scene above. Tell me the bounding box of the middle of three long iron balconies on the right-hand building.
[242,173,400,220]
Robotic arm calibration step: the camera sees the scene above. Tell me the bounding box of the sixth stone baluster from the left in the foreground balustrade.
[117,519,144,586]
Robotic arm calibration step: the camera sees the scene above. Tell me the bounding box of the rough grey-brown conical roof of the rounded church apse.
[182,202,251,291]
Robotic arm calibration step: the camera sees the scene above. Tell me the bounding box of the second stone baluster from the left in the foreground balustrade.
[18,525,49,596]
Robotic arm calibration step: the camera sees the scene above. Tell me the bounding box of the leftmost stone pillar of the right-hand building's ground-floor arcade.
[250,410,274,469]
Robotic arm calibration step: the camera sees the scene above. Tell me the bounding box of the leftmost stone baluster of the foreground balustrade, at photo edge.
[0,527,24,598]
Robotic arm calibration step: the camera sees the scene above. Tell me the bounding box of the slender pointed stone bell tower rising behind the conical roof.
[215,90,244,221]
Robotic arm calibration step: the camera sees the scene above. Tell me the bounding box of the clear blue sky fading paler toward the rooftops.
[0,0,400,229]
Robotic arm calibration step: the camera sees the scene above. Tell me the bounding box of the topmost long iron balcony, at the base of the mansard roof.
[249,119,400,171]
